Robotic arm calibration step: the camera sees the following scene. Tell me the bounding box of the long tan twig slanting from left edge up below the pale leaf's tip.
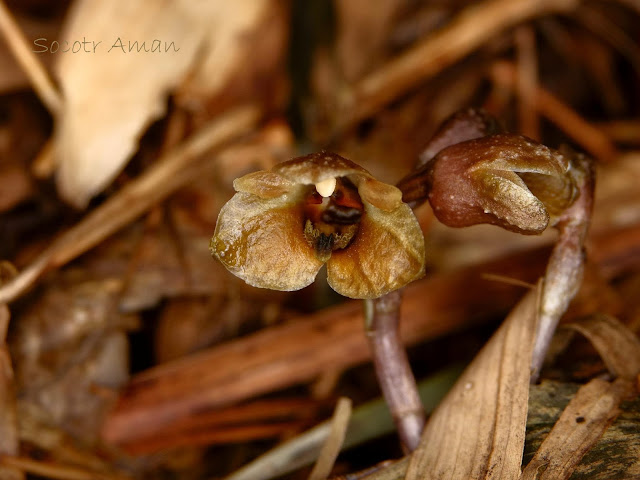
[0,107,260,303]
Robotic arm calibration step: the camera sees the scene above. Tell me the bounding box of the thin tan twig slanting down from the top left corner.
[0,0,62,115]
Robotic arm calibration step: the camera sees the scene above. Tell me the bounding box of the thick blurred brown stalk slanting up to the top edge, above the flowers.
[328,0,579,132]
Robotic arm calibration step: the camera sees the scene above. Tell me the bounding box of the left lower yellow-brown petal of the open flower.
[210,192,322,291]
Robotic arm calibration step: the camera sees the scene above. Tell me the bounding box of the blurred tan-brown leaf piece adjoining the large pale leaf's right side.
[176,0,289,113]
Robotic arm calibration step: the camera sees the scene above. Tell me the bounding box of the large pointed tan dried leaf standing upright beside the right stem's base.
[406,289,538,480]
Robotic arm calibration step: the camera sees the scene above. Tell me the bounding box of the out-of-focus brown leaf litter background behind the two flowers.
[0,0,640,479]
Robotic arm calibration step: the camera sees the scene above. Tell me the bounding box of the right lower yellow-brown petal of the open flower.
[327,203,425,298]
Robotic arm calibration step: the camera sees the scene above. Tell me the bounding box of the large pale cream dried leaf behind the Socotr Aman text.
[56,0,284,207]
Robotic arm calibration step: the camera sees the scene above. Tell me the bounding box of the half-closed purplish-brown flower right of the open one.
[398,133,579,235]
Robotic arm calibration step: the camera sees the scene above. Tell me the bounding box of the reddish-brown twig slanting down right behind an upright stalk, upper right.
[492,62,618,161]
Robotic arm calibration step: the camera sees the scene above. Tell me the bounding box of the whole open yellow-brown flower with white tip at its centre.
[210,152,425,298]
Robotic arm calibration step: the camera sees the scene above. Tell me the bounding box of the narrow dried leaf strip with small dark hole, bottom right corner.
[520,378,633,480]
